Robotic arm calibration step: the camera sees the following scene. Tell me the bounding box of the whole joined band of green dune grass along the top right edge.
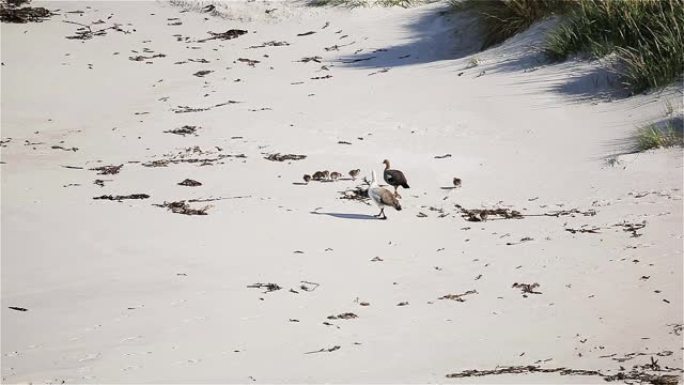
[450,0,684,93]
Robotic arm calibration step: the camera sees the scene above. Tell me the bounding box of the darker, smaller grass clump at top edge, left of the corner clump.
[450,0,573,49]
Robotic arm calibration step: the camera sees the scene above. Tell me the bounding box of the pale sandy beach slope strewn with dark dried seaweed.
[0,2,683,383]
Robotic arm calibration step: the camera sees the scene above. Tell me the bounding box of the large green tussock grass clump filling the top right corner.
[545,0,684,92]
